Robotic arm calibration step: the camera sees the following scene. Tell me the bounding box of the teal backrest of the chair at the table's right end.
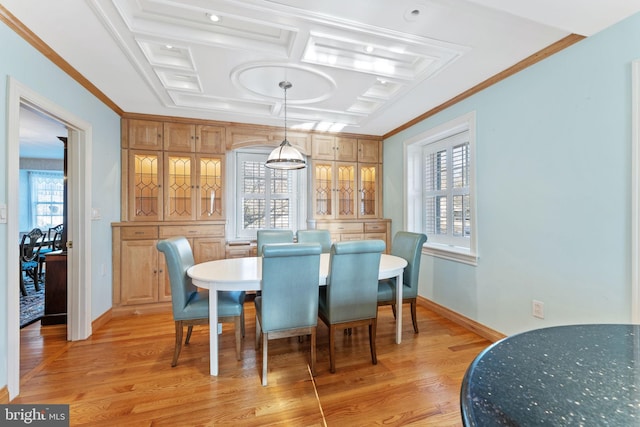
[391,231,427,298]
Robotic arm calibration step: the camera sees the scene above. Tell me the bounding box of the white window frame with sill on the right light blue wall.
[404,112,478,265]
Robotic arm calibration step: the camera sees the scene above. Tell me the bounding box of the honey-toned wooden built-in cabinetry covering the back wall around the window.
[118,114,391,313]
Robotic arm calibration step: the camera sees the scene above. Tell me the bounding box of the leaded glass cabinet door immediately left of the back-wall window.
[197,156,224,220]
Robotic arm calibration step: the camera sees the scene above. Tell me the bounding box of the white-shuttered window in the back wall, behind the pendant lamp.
[236,152,298,239]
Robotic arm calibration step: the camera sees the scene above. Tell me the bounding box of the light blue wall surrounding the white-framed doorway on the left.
[0,23,120,388]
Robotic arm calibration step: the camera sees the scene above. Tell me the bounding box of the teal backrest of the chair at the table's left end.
[156,236,208,320]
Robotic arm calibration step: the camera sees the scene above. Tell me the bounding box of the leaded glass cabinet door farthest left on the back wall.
[129,150,163,221]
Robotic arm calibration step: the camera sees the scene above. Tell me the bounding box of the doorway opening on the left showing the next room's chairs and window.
[18,104,68,328]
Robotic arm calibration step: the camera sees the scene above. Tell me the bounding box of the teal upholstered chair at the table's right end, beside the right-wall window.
[378,231,427,334]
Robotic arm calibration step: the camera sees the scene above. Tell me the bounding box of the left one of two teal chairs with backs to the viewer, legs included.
[255,243,321,386]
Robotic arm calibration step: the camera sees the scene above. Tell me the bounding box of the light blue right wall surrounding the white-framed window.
[383,15,640,334]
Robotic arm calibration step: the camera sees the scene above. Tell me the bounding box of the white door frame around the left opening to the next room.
[5,76,92,400]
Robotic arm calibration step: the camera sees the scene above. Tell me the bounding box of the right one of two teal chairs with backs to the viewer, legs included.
[318,240,385,373]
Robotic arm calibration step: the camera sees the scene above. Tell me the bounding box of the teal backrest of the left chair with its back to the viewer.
[260,243,321,332]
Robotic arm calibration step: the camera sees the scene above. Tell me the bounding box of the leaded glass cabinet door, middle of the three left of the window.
[164,154,195,221]
